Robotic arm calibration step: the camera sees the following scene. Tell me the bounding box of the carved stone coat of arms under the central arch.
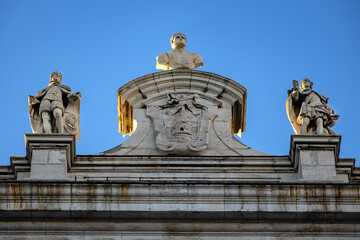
[147,93,217,154]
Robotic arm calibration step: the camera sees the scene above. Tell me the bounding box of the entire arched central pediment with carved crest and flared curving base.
[98,69,267,156]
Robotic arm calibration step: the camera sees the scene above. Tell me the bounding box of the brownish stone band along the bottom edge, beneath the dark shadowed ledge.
[1,221,359,240]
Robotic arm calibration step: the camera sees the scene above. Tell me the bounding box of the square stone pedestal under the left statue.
[25,134,75,180]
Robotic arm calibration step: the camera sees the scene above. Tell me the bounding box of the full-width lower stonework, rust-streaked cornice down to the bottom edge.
[0,181,360,239]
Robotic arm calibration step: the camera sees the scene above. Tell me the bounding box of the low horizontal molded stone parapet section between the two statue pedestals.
[69,155,297,182]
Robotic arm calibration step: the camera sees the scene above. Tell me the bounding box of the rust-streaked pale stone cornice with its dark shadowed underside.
[0,181,360,221]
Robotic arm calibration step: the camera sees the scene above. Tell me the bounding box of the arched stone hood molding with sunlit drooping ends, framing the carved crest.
[118,69,247,135]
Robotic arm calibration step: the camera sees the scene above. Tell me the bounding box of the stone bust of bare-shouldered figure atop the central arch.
[156,33,204,70]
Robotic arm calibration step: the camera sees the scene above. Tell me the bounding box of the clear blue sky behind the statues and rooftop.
[0,0,360,165]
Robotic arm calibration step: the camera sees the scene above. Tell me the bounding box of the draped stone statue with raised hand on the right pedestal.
[286,78,339,135]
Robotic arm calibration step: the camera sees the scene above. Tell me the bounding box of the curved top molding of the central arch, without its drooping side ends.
[118,69,247,108]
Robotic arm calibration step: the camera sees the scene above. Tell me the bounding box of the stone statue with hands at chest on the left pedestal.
[29,72,81,140]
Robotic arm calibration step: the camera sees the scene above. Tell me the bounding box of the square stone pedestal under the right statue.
[290,135,348,182]
